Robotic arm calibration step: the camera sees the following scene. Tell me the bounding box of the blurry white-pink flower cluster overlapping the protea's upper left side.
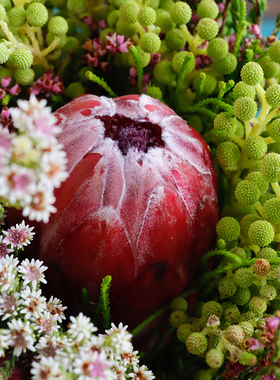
[0,95,68,222]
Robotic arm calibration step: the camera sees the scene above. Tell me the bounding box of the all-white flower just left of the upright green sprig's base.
[68,313,97,342]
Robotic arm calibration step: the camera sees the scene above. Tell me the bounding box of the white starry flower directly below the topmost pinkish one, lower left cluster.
[18,258,48,289]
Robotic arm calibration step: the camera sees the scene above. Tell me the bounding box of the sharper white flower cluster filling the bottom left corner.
[0,226,155,380]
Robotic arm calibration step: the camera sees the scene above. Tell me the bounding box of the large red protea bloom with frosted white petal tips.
[40,95,218,328]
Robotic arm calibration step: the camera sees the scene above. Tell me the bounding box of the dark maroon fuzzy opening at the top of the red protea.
[96,114,164,155]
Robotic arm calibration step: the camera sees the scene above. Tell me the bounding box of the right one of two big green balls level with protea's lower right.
[248,220,274,247]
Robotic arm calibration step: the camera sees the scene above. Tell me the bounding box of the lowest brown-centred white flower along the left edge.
[7,319,36,356]
